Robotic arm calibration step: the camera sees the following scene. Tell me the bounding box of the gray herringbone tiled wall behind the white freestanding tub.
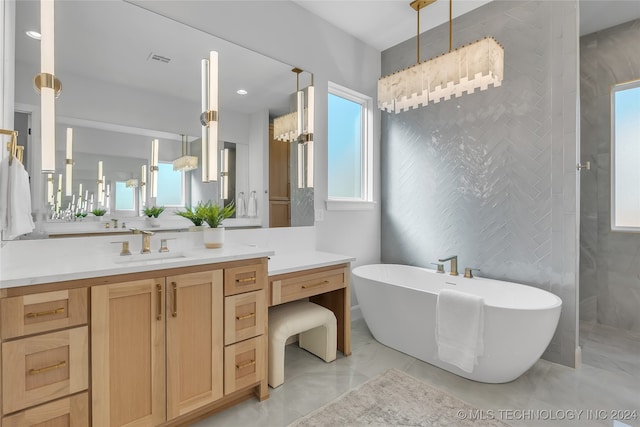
[381,1,578,366]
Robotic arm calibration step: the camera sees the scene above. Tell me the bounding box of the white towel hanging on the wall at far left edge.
[0,156,34,239]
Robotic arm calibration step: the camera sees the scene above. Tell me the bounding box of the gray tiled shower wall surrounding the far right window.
[580,20,640,331]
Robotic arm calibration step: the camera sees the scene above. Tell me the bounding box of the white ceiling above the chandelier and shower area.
[292,0,640,51]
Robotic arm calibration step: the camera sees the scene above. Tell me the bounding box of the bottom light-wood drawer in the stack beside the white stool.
[224,335,266,394]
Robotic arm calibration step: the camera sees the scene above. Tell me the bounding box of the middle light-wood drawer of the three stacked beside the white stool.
[224,289,267,345]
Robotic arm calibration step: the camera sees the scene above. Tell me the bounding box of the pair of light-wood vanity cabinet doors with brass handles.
[91,270,223,427]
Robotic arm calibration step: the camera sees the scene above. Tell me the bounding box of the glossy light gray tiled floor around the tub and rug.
[196,319,640,427]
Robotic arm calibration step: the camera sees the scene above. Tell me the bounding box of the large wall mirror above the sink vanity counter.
[15,0,313,234]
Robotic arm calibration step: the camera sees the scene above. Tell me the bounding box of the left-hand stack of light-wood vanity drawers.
[0,288,89,427]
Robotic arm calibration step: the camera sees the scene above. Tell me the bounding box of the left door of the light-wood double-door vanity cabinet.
[91,279,166,427]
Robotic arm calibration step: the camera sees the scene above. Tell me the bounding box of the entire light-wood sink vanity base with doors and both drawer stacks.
[0,257,268,427]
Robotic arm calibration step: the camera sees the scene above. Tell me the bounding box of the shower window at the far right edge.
[611,80,640,232]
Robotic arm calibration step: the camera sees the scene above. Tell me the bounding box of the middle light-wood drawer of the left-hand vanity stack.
[2,326,89,414]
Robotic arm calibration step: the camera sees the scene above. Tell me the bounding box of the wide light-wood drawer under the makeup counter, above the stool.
[270,268,349,305]
